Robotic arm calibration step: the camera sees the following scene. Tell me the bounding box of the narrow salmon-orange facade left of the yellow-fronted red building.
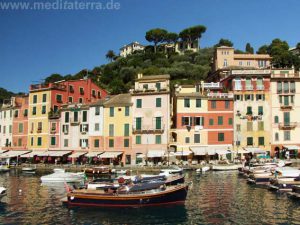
[12,95,29,150]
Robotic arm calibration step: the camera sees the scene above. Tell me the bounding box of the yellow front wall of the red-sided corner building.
[28,90,51,150]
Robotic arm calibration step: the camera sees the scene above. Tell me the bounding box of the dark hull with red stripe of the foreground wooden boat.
[67,185,188,207]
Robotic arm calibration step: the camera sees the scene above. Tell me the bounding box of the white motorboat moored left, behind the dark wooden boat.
[41,169,85,183]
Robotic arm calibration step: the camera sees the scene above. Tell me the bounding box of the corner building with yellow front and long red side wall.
[28,79,106,150]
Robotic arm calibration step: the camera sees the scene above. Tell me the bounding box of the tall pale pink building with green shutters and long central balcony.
[131,74,171,162]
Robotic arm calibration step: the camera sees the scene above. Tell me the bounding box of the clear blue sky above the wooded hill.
[0,0,300,92]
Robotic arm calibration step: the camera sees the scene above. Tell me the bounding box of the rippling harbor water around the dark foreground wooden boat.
[0,170,300,225]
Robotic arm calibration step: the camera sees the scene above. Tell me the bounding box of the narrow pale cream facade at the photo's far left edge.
[0,98,14,150]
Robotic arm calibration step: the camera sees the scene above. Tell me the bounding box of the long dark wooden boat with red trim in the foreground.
[66,184,188,207]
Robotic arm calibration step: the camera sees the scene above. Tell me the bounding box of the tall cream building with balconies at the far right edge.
[270,69,300,157]
